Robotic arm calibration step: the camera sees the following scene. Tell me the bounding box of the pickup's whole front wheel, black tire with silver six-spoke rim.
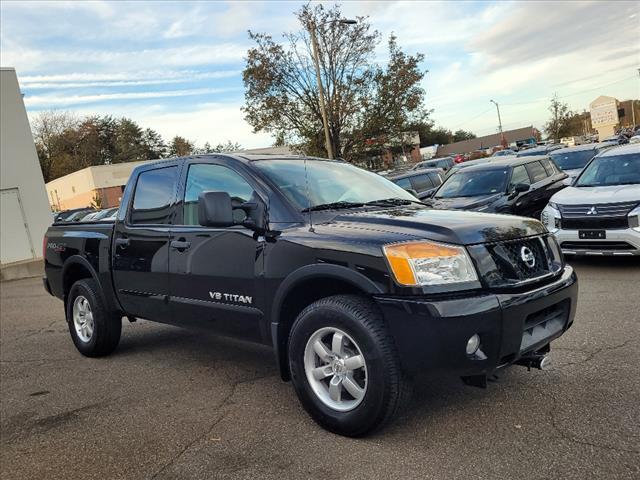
[289,295,408,437]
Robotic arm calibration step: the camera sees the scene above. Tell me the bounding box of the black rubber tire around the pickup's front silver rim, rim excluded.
[289,295,409,437]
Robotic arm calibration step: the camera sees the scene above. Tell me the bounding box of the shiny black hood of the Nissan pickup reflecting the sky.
[324,206,546,245]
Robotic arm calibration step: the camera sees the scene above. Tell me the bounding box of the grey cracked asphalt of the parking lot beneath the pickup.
[0,258,640,480]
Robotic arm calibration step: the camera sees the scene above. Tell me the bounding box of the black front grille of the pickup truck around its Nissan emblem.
[488,237,551,282]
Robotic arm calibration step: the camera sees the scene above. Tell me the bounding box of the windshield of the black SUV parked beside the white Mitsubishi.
[435,168,509,198]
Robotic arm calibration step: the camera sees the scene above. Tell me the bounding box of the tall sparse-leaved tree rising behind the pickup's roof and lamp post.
[243,4,427,158]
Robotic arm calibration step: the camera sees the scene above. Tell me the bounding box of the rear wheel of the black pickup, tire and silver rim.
[67,279,122,357]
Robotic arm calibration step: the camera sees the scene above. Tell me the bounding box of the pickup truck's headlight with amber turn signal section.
[382,241,478,286]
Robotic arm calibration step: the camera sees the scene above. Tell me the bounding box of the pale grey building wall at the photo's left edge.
[0,68,53,265]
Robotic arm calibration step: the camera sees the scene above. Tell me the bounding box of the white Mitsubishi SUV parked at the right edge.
[541,144,640,255]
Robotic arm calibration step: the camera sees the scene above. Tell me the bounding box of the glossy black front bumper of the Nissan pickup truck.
[375,266,578,376]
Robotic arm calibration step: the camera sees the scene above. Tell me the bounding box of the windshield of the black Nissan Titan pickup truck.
[253,160,417,210]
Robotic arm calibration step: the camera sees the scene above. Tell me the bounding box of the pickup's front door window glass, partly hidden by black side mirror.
[182,163,253,225]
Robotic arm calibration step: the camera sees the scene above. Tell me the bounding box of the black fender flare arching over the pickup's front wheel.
[270,264,383,381]
